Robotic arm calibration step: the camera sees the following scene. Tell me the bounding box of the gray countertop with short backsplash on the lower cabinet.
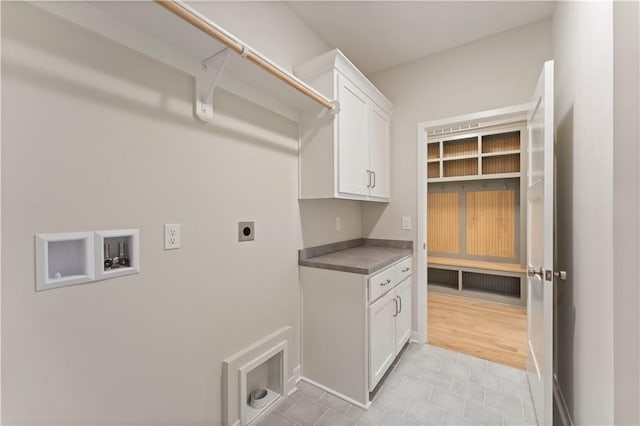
[298,238,413,275]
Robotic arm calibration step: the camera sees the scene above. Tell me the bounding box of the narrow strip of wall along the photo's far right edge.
[613,2,640,425]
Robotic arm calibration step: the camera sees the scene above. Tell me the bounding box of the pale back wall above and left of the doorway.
[362,20,551,328]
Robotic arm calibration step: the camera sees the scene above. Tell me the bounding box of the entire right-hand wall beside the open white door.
[553,2,640,424]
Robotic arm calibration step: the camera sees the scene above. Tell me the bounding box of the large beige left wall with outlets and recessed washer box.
[2,2,361,425]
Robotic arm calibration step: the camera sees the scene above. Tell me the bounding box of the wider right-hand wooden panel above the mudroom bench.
[468,190,516,258]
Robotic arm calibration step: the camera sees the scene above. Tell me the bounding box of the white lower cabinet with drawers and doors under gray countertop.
[300,257,412,407]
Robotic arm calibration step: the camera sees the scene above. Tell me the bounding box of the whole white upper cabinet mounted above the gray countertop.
[294,49,393,202]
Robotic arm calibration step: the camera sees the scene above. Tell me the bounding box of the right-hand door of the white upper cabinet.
[369,104,391,198]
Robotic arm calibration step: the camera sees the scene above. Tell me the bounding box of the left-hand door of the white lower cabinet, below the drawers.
[369,291,397,391]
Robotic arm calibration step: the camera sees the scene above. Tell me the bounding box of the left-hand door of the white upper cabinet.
[337,74,369,196]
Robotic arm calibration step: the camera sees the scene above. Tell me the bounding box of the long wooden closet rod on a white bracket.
[154,0,334,110]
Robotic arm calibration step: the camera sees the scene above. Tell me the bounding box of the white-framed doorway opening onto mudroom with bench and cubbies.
[417,105,529,369]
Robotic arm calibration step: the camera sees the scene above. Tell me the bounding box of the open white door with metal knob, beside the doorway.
[527,61,554,425]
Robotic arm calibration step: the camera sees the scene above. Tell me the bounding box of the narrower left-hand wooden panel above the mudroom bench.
[427,192,460,253]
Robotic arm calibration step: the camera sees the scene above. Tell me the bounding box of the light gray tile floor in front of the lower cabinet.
[257,344,536,426]
